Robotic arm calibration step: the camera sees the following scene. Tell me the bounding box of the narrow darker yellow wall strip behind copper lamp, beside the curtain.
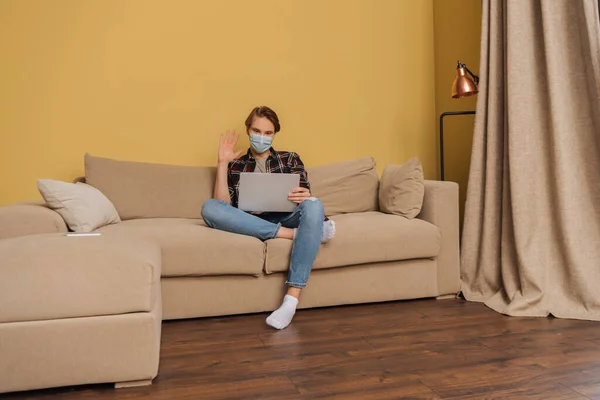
[433,0,481,230]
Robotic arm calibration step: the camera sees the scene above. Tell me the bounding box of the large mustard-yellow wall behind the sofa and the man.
[0,0,436,204]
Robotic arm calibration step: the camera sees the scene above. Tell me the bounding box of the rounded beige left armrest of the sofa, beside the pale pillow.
[0,202,68,239]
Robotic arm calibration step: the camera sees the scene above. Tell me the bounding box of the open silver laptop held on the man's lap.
[238,172,300,212]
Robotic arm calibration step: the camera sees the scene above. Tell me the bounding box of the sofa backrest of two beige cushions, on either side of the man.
[85,154,379,220]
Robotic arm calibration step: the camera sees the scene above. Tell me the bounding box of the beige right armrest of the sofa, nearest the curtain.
[417,180,460,296]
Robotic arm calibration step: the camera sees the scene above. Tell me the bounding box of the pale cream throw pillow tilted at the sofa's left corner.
[38,179,121,233]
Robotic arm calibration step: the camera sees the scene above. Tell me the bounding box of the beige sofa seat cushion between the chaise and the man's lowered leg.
[99,218,265,277]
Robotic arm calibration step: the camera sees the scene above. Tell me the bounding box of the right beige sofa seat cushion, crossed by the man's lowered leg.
[265,211,441,273]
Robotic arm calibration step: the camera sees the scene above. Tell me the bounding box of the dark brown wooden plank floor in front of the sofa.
[0,300,600,400]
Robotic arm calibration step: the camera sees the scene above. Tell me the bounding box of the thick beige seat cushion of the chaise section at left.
[0,234,161,322]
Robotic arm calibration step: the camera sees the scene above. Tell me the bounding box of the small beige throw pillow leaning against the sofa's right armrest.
[379,157,425,218]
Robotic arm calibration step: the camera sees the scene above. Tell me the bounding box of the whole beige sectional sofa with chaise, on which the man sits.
[0,155,459,392]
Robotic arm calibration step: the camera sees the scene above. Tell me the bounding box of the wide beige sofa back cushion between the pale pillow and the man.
[85,154,216,220]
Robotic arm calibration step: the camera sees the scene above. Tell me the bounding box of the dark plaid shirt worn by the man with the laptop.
[227,147,310,207]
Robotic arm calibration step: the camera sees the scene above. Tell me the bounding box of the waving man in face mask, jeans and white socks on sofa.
[202,107,335,329]
